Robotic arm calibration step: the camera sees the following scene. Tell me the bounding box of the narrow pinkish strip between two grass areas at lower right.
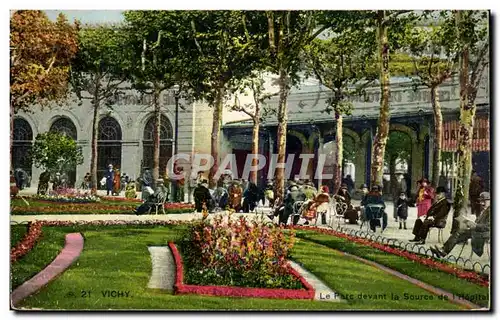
[336,248,487,309]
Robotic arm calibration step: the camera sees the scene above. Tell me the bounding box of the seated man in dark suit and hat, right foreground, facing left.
[410,187,451,244]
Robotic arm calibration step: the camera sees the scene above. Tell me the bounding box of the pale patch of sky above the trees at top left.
[44,10,124,24]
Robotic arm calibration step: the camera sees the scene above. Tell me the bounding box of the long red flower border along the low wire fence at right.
[291,226,489,287]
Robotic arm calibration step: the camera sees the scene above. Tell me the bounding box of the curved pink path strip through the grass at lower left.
[10,233,83,308]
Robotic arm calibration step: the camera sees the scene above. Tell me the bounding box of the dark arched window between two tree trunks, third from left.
[97,116,122,180]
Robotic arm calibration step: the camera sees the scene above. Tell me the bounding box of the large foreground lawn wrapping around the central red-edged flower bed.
[13,226,460,310]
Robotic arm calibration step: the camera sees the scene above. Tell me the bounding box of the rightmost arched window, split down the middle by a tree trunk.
[142,115,173,176]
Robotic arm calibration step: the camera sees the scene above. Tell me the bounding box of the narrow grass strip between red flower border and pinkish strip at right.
[296,230,489,307]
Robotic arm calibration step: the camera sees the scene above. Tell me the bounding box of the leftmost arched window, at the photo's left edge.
[12,118,33,176]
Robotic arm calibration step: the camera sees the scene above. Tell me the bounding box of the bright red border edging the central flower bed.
[168,242,315,299]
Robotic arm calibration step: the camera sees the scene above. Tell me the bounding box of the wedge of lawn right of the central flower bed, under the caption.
[292,239,461,310]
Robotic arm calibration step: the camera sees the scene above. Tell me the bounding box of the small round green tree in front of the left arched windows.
[30,131,83,172]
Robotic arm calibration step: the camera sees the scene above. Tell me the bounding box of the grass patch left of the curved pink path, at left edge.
[10,225,68,289]
